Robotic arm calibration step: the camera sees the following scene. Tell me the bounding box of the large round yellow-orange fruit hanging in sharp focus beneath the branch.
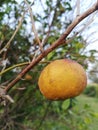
[38,59,87,100]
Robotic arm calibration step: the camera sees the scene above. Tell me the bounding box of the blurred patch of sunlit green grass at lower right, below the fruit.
[74,95,98,130]
